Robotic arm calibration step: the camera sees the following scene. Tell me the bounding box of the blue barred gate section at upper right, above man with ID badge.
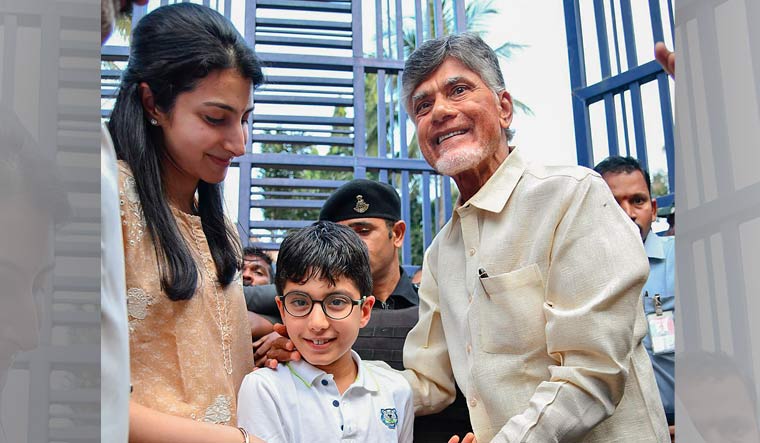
[564,0,675,207]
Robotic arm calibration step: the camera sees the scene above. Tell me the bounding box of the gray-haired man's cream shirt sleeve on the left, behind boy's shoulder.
[402,246,456,415]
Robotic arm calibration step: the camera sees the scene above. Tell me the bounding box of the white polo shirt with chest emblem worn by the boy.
[238,351,414,443]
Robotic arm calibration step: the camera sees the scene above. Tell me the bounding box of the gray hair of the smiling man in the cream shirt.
[401,32,513,140]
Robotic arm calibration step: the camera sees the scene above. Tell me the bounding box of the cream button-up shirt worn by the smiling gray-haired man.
[404,150,670,443]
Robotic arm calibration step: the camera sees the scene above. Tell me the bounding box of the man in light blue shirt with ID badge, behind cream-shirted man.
[594,156,676,436]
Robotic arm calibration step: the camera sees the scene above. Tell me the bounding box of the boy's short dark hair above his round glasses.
[274,221,372,297]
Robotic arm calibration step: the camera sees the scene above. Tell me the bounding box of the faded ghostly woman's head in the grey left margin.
[0,102,70,442]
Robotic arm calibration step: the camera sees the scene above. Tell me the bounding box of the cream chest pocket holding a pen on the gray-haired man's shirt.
[475,264,546,354]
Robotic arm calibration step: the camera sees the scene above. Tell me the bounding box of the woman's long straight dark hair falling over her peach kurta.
[108,3,264,300]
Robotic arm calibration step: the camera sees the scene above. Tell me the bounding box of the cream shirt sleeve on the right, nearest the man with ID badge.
[496,175,649,443]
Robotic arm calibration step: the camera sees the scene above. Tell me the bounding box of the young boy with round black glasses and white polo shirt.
[238,221,414,443]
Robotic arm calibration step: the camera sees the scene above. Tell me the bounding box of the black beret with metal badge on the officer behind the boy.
[319,178,401,222]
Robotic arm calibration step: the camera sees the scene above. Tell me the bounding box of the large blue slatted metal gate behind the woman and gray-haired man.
[102,0,472,266]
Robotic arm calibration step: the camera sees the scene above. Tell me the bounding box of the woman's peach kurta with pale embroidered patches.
[119,162,253,425]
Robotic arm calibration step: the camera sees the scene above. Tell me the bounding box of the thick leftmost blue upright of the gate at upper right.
[563,0,594,166]
